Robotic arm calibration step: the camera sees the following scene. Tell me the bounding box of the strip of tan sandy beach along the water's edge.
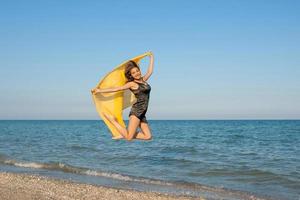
[0,172,203,200]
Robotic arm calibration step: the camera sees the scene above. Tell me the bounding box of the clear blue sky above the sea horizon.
[0,0,300,120]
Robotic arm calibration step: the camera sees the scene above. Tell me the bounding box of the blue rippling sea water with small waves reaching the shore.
[0,120,300,200]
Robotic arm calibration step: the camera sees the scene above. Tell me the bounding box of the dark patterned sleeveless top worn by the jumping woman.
[129,81,151,119]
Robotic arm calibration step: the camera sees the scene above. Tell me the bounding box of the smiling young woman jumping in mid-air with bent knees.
[92,53,154,140]
